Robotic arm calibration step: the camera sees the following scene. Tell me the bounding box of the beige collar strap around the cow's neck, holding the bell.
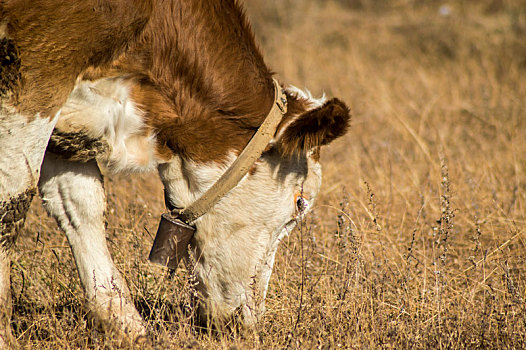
[178,79,287,224]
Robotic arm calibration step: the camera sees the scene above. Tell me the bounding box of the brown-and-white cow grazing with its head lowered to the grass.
[0,0,350,346]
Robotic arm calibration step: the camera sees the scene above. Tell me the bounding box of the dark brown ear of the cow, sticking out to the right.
[274,98,351,157]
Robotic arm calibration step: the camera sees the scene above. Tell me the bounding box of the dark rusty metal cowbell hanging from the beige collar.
[148,213,196,270]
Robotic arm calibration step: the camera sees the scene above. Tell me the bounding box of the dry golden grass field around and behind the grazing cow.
[12,0,526,349]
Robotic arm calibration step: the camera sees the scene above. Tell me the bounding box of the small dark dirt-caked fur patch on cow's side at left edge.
[0,38,20,101]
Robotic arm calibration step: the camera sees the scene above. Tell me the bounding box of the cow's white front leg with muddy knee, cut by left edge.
[0,106,57,349]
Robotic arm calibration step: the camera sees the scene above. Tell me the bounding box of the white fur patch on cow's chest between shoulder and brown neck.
[57,77,158,172]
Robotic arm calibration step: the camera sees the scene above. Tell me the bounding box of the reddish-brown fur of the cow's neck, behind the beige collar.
[117,0,274,162]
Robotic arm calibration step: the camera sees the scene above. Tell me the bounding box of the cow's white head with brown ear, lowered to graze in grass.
[159,88,350,324]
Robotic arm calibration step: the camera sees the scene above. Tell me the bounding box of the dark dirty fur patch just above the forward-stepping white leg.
[46,129,109,162]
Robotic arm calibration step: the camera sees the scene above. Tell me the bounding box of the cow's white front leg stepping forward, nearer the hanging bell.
[39,152,146,340]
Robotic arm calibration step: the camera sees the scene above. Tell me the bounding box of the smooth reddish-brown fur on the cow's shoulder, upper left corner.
[0,0,152,116]
